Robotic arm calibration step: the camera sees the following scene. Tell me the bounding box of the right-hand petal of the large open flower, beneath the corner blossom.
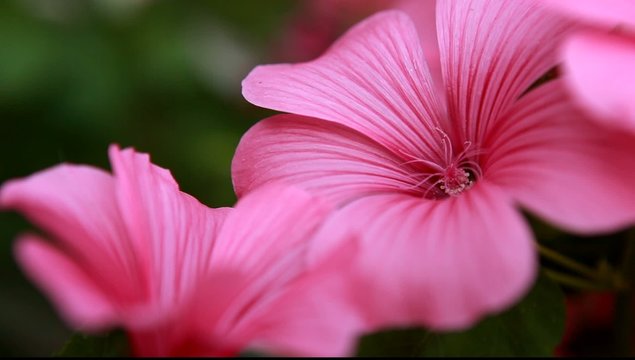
[484,81,635,234]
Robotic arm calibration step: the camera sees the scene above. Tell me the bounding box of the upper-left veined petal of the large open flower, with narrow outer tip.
[243,11,444,160]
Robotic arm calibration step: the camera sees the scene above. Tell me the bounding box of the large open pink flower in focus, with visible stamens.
[232,0,635,329]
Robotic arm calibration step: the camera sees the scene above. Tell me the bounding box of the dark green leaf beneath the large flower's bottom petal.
[358,275,565,357]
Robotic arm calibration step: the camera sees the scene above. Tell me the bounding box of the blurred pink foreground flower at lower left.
[0,146,361,356]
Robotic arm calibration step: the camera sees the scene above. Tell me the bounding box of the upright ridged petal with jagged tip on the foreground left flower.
[109,146,230,322]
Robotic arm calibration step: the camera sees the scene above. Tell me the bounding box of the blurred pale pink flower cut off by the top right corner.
[548,0,635,132]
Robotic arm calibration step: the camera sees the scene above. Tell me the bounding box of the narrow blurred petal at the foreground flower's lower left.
[15,235,120,331]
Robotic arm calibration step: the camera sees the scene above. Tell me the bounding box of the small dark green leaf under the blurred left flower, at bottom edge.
[55,330,130,357]
